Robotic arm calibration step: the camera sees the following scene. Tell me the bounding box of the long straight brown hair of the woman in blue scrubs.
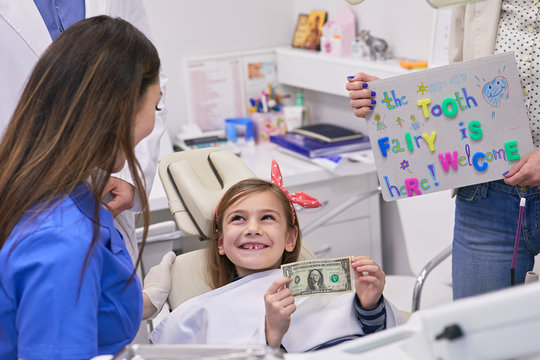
[0,16,160,272]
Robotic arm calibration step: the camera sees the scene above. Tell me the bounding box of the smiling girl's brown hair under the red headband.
[206,178,302,289]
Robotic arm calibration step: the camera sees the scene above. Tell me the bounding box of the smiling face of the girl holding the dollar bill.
[218,191,297,276]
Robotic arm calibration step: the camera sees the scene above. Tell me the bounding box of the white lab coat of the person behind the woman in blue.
[0,0,167,258]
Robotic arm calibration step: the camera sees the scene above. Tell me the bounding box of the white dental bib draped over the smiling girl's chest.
[150,269,403,352]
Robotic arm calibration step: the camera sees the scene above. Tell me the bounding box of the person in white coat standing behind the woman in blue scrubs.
[0,0,166,262]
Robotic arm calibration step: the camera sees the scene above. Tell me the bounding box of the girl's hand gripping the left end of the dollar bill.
[264,277,296,348]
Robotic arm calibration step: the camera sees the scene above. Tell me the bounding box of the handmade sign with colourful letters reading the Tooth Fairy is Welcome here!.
[366,52,534,201]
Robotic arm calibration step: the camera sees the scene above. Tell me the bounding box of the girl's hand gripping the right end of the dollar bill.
[351,256,386,309]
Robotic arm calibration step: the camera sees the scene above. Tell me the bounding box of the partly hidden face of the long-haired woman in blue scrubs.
[113,81,161,172]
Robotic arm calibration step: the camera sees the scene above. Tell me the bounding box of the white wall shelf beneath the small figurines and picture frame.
[276,47,411,97]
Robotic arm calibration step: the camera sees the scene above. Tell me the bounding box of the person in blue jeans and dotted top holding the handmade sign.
[346,0,540,299]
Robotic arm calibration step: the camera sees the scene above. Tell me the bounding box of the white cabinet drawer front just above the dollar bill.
[302,217,378,261]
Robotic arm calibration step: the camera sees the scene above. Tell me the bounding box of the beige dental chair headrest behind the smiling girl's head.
[158,148,255,238]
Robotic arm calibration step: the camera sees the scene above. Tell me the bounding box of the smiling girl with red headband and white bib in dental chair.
[150,161,401,352]
